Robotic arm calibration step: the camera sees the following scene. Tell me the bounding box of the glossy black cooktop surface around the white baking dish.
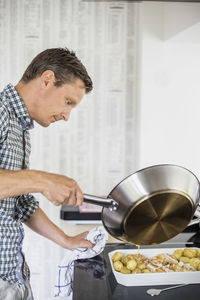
[73,226,200,300]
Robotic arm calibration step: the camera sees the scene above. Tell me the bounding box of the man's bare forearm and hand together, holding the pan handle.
[0,169,83,205]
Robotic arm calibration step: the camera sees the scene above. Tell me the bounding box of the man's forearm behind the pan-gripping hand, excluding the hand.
[0,169,42,199]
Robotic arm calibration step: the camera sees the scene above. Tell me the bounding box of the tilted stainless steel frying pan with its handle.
[84,165,200,245]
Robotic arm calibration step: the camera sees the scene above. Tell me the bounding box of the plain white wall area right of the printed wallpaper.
[138,2,200,176]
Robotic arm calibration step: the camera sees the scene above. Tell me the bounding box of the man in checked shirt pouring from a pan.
[0,48,93,300]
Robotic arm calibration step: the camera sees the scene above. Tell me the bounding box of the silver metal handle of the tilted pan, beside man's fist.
[83,194,118,211]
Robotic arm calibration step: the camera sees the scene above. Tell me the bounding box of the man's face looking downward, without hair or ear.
[33,79,85,127]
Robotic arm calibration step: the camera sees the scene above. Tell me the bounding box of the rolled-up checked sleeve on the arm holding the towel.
[18,194,39,223]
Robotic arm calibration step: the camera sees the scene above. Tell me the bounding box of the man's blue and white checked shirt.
[0,84,39,284]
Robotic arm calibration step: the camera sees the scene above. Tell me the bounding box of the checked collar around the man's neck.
[4,83,34,129]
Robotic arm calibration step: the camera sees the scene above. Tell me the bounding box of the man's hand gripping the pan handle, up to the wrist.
[41,172,83,206]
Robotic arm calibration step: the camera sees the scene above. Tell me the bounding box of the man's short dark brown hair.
[21,48,93,93]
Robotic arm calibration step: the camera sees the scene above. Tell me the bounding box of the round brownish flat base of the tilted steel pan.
[123,191,194,245]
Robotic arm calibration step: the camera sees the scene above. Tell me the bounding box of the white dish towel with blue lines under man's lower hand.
[54,226,108,300]
